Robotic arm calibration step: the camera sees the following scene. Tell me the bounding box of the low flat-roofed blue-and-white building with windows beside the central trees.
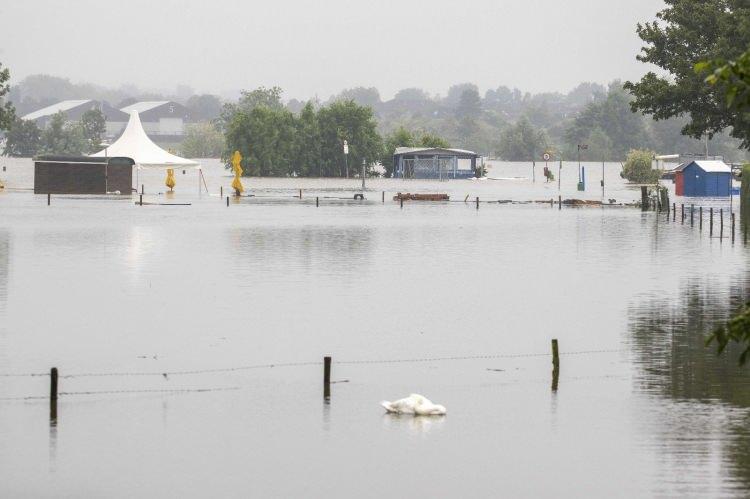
[393,147,479,180]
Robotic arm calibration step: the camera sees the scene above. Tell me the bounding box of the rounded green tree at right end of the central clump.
[318,100,383,177]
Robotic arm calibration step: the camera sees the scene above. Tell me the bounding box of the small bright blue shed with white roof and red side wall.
[674,160,732,197]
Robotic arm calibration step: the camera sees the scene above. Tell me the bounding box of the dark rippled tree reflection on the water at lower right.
[628,277,750,493]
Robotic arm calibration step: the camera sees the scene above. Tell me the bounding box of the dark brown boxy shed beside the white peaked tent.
[34,155,135,195]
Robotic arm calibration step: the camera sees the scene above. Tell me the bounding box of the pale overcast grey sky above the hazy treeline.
[0,0,663,98]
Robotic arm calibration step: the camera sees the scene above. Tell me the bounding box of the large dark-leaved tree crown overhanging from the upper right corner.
[625,0,750,148]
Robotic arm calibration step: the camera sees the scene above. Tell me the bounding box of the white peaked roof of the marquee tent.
[91,111,200,168]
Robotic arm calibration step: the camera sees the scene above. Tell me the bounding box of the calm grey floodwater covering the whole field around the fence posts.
[0,159,750,497]
